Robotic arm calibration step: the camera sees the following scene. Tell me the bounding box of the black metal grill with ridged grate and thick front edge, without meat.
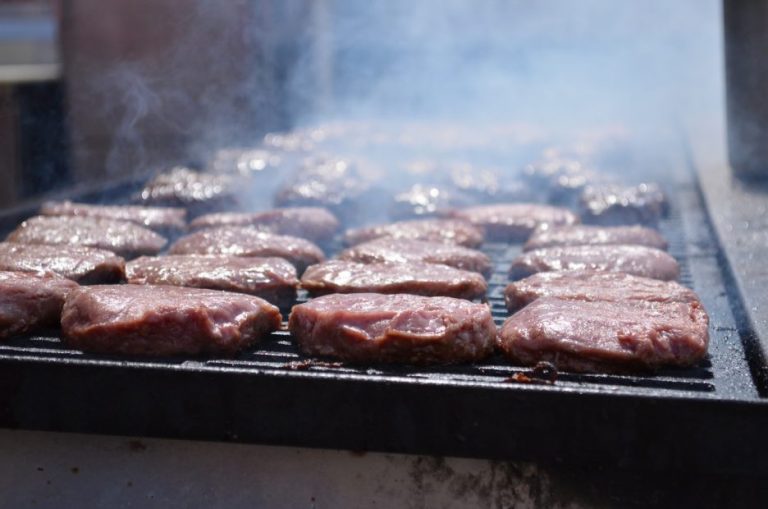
[0,153,768,474]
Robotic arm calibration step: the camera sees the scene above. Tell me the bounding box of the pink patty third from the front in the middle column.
[337,237,493,277]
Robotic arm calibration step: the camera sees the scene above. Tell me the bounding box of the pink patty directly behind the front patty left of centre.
[126,255,299,307]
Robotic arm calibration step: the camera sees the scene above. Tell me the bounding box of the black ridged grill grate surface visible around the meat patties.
[0,179,757,399]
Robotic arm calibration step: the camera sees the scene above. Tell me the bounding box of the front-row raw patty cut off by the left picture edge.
[0,271,78,338]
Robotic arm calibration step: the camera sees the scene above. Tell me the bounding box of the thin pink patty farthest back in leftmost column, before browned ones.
[40,201,187,232]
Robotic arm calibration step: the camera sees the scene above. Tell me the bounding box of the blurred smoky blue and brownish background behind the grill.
[0,0,723,206]
